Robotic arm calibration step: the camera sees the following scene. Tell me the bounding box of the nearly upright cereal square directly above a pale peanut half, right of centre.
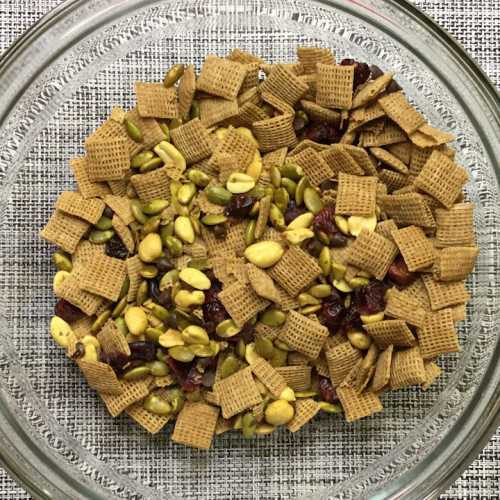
[335,172,378,217]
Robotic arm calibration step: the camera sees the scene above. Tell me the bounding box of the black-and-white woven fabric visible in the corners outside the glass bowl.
[0,0,500,500]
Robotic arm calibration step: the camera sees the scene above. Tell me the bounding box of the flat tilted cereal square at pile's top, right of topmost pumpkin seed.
[196,55,246,101]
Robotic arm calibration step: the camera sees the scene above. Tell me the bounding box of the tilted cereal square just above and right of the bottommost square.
[214,366,262,418]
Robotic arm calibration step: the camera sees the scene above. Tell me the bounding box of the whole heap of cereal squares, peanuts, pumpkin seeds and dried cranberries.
[40,47,479,449]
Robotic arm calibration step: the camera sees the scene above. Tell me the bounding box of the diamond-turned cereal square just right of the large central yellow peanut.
[268,245,322,297]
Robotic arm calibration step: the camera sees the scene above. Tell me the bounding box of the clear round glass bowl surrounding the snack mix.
[0,0,500,500]
